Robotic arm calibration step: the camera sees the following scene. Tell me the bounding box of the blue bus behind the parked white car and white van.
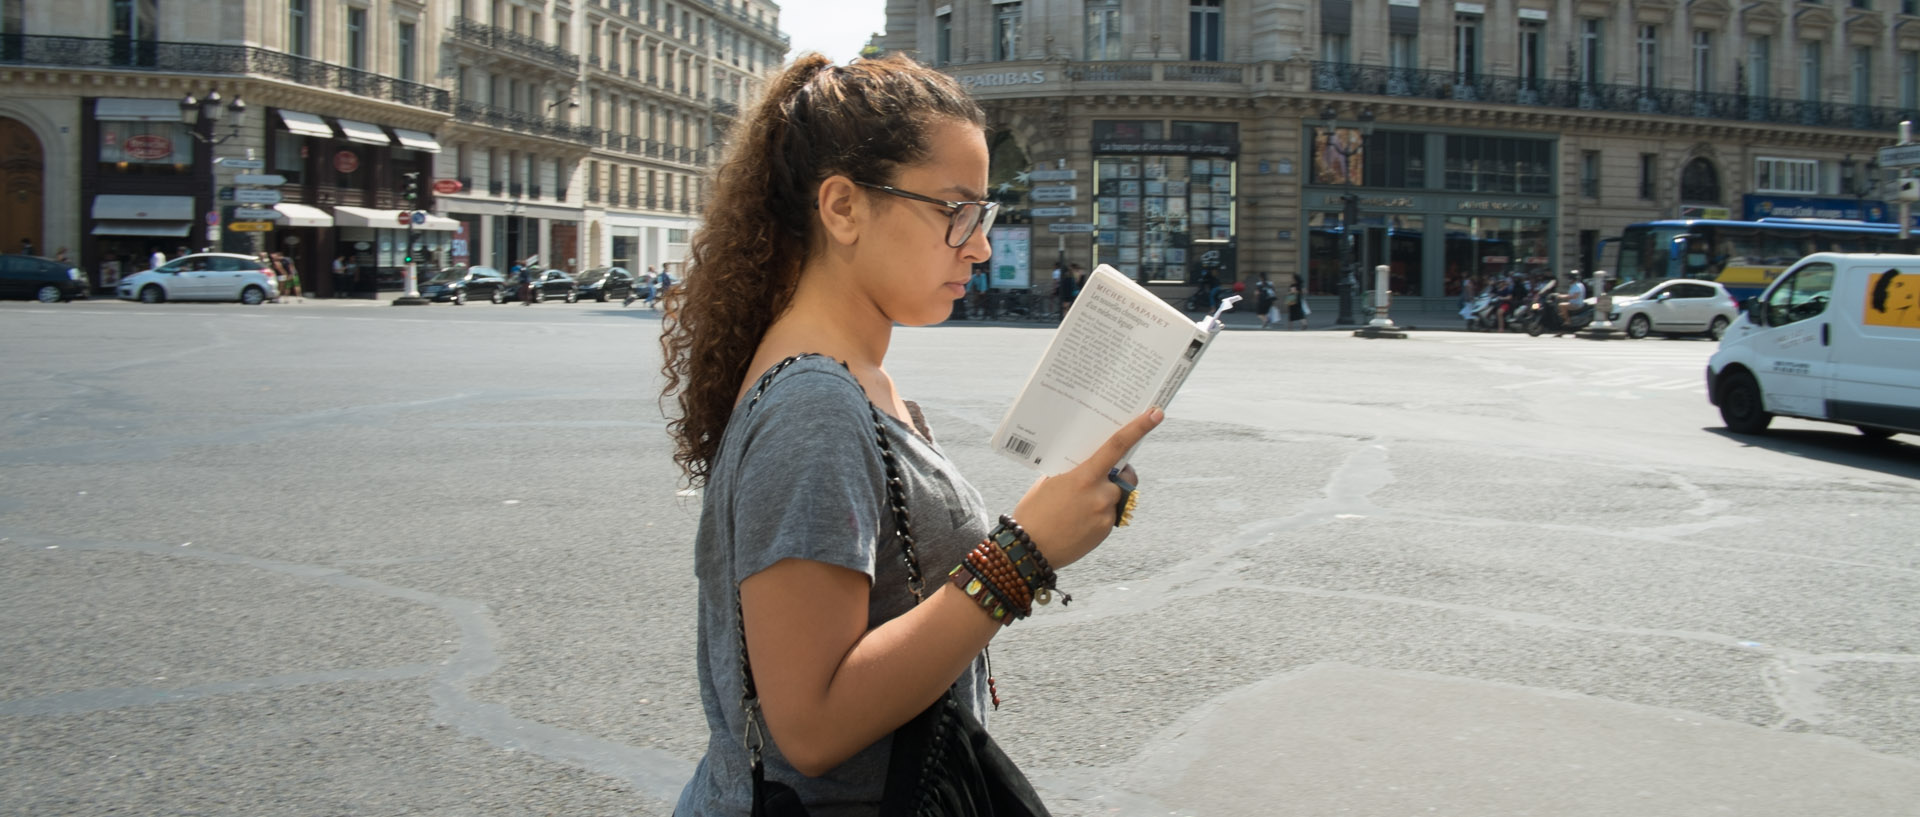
[1611,217,1920,299]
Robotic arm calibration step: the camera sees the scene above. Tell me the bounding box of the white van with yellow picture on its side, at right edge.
[1707,253,1920,437]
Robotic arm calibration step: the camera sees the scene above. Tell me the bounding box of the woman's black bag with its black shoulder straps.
[733,355,1050,817]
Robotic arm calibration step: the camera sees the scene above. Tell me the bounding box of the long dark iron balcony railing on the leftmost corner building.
[0,35,451,113]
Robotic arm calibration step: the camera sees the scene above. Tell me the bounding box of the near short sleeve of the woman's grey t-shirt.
[732,361,887,585]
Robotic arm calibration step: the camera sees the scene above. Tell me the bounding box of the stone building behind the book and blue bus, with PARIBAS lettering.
[876,0,1920,303]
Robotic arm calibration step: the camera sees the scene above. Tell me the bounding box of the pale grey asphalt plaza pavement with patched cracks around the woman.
[0,303,1920,815]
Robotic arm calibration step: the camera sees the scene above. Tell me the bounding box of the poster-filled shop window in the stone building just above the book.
[1094,155,1238,282]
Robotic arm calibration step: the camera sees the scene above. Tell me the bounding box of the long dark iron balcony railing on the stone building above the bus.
[1313,61,1916,130]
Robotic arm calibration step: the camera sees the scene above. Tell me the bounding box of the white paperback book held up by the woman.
[993,265,1219,474]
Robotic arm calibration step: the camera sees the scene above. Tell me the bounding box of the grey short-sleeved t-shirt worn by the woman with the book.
[674,357,989,817]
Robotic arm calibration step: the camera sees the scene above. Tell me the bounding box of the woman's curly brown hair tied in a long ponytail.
[660,54,987,485]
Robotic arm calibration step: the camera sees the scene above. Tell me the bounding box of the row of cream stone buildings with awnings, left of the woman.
[0,0,787,295]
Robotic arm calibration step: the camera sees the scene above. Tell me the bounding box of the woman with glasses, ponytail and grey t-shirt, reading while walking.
[660,54,1162,817]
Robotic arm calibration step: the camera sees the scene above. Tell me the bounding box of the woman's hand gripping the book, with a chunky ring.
[1014,409,1165,570]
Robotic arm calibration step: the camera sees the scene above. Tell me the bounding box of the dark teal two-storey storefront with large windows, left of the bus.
[1300,127,1559,301]
